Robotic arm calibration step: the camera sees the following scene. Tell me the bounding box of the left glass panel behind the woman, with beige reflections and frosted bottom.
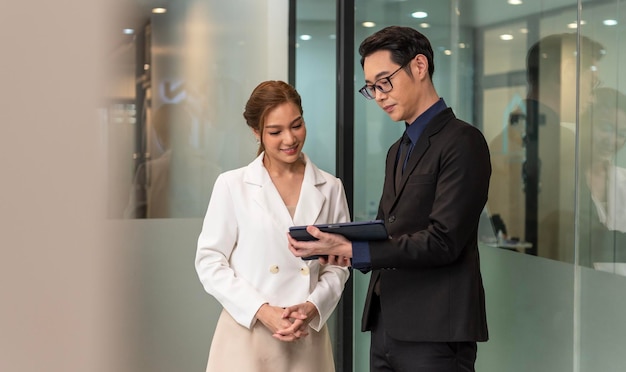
[98,0,288,372]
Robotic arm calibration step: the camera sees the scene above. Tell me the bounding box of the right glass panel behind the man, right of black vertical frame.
[346,0,626,371]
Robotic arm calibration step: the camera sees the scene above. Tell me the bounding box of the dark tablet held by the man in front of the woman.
[289,220,389,260]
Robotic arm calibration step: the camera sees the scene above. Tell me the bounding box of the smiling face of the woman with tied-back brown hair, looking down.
[260,102,306,164]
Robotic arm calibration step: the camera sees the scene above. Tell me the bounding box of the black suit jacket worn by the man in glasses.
[361,108,491,342]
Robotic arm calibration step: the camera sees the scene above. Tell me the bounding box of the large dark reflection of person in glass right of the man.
[488,33,604,261]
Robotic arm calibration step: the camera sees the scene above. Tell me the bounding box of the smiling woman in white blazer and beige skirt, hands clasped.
[195,81,350,372]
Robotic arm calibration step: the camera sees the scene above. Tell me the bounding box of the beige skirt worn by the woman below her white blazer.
[206,310,335,372]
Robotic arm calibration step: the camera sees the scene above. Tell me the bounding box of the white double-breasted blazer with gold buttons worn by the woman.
[195,154,350,331]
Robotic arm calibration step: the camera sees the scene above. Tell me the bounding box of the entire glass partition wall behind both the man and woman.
[99,0,626,372]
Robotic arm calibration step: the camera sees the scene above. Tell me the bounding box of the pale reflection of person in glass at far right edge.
[580,88,626,271]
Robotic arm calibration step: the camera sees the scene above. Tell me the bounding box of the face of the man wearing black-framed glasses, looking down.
[363,50,420,123]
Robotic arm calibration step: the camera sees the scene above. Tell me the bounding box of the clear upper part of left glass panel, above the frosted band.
[106,0,287,218]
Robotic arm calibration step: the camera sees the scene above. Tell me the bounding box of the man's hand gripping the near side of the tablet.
[287,225,352,260]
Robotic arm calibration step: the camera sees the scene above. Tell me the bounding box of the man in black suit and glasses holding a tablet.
[289,26,491,372]
